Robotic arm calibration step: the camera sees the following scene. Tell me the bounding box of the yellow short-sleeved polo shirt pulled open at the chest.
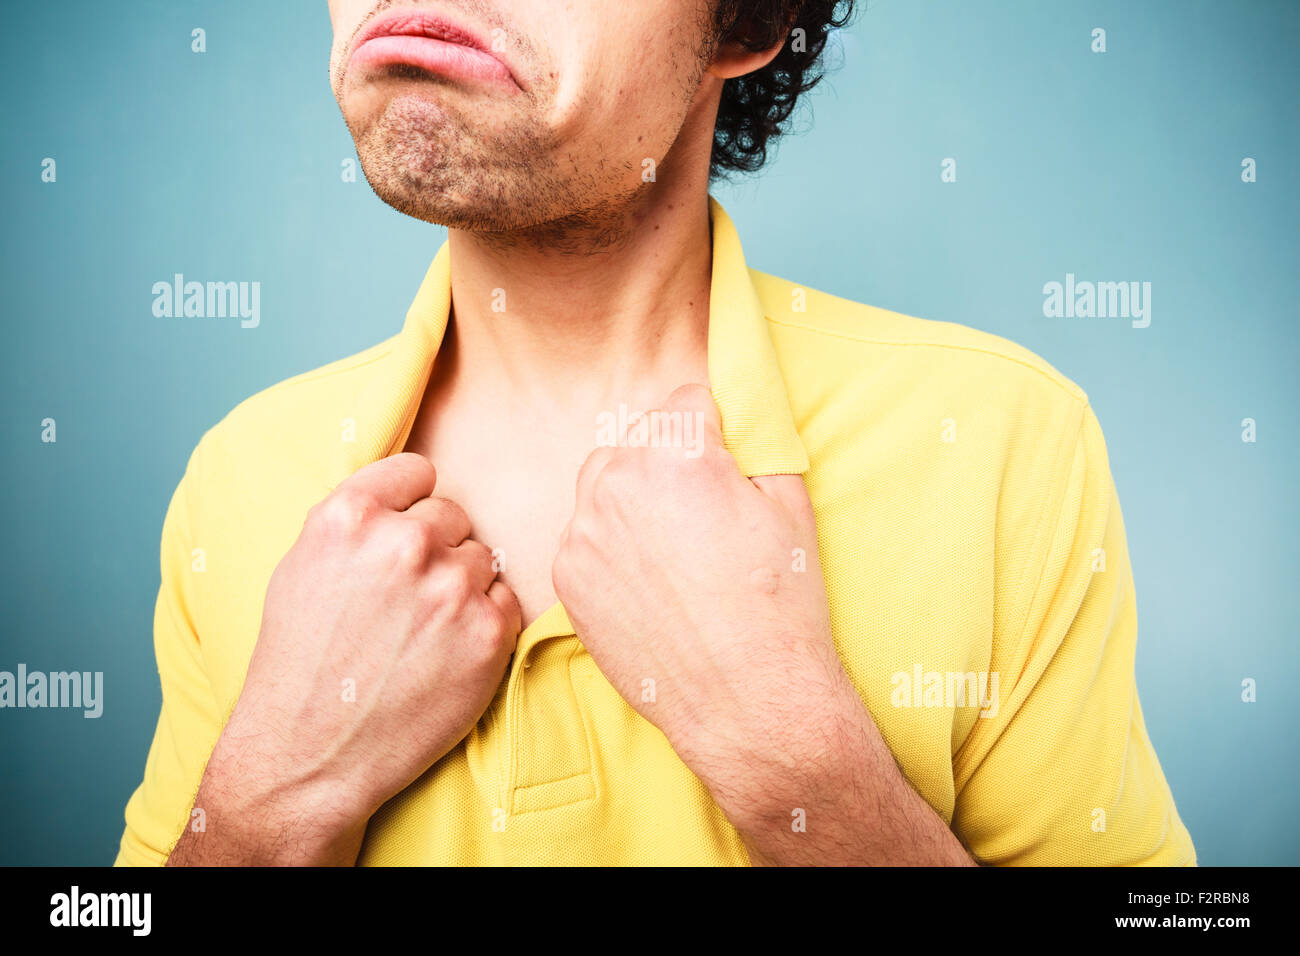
[117,196,1196,865]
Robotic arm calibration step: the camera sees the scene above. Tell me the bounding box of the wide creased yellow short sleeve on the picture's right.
[952,405,1196,866]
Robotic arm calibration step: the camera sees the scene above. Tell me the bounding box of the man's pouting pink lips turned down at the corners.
[348,10,523,92]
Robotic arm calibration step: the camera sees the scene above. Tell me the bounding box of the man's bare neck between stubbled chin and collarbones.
[436,182,712,405]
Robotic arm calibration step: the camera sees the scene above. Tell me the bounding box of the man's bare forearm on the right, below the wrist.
[706,678,975,866]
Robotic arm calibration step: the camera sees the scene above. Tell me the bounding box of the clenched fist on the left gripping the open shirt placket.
[211,454,520,821]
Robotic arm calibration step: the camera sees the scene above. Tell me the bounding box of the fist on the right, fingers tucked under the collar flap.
[553,385,848,783]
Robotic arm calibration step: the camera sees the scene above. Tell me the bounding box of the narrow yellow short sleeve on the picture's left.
[114,441,224,866]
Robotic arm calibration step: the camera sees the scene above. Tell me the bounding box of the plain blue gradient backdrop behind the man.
[0,0,1300,865]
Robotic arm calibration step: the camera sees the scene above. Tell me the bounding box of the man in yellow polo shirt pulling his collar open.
[118,0,1195,865]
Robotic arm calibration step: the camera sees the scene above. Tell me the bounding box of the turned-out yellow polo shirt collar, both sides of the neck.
[333,195,809,484]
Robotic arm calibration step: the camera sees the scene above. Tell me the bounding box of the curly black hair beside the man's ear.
[709,0,854,181]
